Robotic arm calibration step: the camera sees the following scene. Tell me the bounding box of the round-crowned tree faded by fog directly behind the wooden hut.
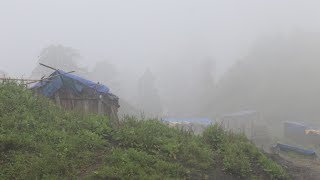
[31,45,81,78]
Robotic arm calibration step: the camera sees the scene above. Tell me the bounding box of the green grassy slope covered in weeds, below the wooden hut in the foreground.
[0,84,288,179]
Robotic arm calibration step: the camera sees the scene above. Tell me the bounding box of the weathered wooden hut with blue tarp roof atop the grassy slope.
[31,70,120,124]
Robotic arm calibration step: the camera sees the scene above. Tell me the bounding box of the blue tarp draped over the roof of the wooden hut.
[32,70,110,97]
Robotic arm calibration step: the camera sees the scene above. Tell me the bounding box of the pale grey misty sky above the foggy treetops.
[0,0,320,76]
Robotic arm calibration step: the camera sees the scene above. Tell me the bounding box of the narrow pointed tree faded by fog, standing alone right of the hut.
[138,69,162,116]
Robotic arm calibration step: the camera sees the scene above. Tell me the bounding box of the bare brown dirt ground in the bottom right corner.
[269,154,320,180]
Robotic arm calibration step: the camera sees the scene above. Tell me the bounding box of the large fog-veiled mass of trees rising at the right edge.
[213,33,320,122]
